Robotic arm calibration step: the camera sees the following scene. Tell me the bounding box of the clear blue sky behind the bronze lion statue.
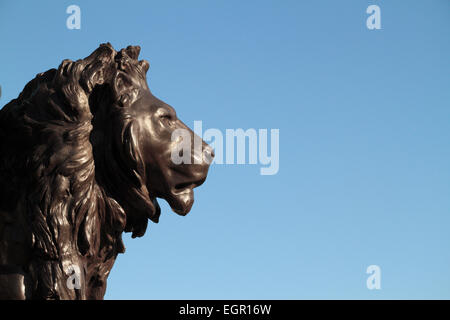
[0,0,450,299]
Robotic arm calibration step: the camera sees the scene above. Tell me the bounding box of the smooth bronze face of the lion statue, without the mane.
[131,90,214,215]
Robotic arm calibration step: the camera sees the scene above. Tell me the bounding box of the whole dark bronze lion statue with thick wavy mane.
[0,43,214,299]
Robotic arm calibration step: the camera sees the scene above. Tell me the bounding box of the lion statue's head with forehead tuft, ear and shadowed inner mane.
[90,43,213,236]
